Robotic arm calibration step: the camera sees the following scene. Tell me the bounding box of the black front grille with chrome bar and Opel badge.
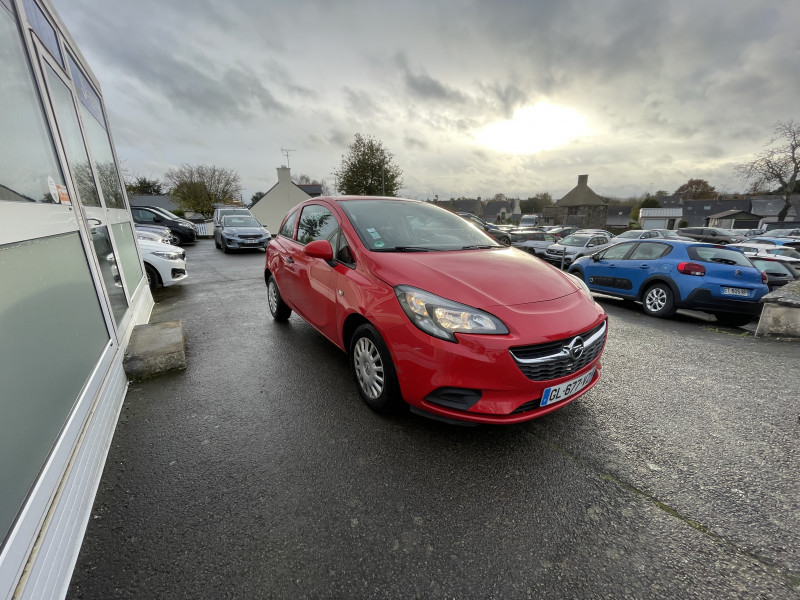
[509,321,606,381]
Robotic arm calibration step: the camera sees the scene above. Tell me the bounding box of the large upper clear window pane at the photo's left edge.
[0,10,66,203]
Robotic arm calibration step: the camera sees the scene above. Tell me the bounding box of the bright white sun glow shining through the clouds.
[476,102,590,154]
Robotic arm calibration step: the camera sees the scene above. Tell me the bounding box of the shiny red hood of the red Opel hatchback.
[369,248,578,308]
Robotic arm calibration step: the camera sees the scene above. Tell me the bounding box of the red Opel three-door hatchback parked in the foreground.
[264,196,607,423]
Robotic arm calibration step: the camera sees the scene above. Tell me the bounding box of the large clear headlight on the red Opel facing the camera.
[394,285,508,342]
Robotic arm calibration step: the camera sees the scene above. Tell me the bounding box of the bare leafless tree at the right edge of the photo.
[736,119,800,221]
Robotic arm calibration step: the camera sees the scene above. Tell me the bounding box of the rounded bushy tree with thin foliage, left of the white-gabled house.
[164,164,242,217]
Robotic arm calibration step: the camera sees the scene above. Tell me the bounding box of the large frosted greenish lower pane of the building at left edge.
[0,233,109,539]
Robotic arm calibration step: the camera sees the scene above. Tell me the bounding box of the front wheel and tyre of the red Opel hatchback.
[350,323,400,414]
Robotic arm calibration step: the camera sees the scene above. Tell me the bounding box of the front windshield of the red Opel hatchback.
[340,200,504,252]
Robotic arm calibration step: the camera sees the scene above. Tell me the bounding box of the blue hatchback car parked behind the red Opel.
[569,239,768,326]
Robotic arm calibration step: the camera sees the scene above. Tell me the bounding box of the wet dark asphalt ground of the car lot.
[68,240,800,600]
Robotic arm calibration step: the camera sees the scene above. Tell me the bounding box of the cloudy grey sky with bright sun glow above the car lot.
[52,0,800,201]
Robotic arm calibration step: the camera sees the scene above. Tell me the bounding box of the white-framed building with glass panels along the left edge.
[0,0,153,600]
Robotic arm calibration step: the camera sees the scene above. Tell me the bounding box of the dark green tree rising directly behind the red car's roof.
[334,133,403,196]
